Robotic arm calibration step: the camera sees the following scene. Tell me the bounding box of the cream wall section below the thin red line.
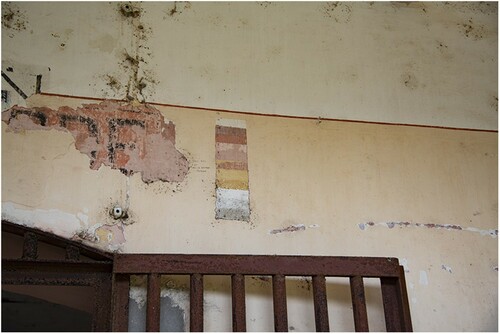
[2,96,498,331]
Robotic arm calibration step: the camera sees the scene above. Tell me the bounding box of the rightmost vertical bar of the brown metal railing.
[380,277,403,332]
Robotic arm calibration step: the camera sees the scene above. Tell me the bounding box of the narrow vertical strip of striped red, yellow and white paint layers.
[215,119,250,221]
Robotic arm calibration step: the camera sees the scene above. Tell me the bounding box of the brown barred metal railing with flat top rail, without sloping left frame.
[112,254,412,332]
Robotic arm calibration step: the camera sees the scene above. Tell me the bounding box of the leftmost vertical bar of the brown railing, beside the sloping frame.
[111,274,130,332]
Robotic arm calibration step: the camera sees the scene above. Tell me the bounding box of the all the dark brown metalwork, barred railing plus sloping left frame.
[2,221,412,332]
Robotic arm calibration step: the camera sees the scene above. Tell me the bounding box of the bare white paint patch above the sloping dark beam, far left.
[2,202,88,238]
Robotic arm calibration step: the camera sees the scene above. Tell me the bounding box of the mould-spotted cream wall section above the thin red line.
[2,2,498,129]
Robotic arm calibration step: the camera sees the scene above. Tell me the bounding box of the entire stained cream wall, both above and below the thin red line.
[2,2,498,331]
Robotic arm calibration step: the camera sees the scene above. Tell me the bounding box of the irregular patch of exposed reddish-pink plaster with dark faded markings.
[2,101,188,183]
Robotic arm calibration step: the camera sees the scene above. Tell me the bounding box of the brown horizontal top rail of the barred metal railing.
[113,254,399,277]
